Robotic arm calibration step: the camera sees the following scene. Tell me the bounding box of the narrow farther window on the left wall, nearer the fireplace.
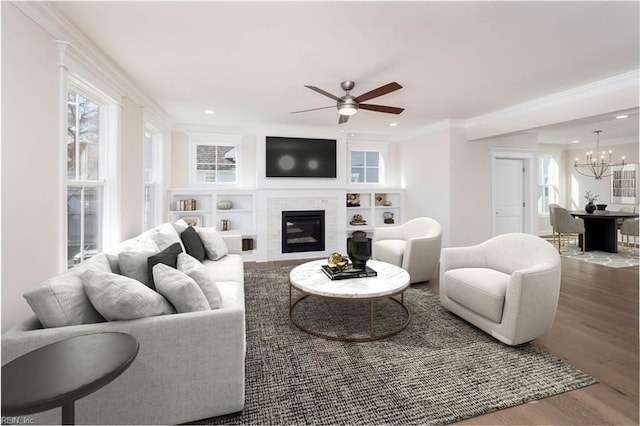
[143,128,161,229]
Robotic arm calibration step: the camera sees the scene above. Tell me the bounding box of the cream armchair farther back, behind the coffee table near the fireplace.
[371,217,442,283]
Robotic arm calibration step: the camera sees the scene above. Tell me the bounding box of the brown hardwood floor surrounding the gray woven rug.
[245,258,640,425]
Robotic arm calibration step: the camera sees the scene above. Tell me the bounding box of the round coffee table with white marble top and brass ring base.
[289,260,411,342]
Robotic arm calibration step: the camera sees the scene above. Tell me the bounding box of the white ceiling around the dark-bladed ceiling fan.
[53,1,640,143]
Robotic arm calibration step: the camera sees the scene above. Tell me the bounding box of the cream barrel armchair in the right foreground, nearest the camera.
[440,233,560,345]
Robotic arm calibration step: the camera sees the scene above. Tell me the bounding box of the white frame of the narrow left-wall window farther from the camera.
[142,124,163,229]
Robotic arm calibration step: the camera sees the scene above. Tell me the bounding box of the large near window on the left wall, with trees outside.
[67,89,104,267]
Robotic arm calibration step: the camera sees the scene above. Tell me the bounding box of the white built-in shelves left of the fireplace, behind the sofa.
[168,188,258,260]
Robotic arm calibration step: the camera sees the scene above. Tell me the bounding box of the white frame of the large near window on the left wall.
[63,76,120,262]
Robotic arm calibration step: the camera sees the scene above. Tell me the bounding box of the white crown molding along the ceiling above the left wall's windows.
[11,1,173,127]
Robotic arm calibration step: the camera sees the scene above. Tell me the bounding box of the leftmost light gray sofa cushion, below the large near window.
[23,253,111,328]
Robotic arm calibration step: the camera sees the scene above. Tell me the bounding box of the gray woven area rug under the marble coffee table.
[203,267,597,425]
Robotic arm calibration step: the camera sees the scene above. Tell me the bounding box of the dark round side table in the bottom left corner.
[2,332,139,424]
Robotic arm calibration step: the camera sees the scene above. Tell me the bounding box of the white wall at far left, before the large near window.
[1,2,64,331]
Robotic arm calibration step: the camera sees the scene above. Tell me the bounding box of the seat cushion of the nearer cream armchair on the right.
[444,268,511,323]
